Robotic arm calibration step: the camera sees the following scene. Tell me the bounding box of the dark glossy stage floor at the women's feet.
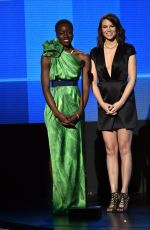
[0,196,150,230]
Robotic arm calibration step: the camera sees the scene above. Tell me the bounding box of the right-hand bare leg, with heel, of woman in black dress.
[117,129,132,212]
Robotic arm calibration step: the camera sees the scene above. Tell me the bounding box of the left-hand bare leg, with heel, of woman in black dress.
[102,131,118,212]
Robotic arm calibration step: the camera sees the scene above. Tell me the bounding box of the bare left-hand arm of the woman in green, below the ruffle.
[41,56,69,125]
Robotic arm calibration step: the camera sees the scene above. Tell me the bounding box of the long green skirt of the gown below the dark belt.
[44,86,86,214]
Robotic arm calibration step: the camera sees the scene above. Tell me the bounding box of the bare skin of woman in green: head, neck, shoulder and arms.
[41,22,90,126]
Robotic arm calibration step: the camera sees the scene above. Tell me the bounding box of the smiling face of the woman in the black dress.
[101,19,117,41]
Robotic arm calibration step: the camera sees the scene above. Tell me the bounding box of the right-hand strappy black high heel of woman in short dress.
[117,193,129,212]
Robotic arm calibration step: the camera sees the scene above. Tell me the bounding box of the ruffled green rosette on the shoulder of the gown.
[43,39,63,58]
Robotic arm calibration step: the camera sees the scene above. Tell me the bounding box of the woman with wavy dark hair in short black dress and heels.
[91,14,137,212]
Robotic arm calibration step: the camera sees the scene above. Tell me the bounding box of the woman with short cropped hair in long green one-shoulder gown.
[41,19,90,214]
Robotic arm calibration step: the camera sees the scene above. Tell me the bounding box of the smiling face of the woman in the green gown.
[56,22,73,48]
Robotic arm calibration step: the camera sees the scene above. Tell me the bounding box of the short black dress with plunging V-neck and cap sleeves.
[91,43,137,131]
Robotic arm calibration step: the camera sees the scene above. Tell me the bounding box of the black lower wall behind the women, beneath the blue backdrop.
[0,121,150,207]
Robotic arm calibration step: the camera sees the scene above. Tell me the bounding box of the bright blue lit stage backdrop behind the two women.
[0,0,150,124]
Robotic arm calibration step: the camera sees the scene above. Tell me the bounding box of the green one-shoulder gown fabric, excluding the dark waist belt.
[43,40,86,214]
